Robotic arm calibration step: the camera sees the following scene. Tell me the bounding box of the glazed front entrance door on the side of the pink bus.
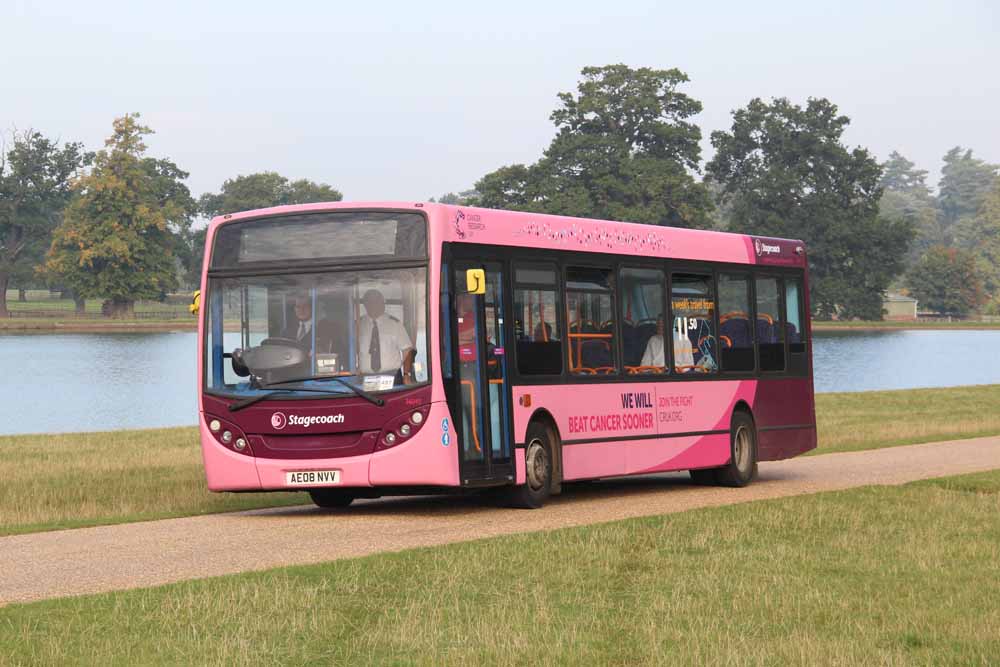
[452,263,514,486]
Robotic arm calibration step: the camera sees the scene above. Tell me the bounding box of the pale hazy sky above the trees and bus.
[0,0,1000,200]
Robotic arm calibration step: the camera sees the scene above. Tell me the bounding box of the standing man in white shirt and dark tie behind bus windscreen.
[358,289,417,384]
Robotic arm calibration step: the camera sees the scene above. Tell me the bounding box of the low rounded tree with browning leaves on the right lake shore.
[906,245,985,317]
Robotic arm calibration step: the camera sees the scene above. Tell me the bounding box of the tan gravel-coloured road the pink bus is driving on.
[0,437,1000,605]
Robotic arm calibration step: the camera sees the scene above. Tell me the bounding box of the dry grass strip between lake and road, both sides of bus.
[0,385,1000,535]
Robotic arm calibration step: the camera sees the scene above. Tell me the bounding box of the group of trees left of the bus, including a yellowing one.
[0,114,343,317]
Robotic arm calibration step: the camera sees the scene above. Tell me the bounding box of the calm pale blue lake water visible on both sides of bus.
[0,331,1000,434]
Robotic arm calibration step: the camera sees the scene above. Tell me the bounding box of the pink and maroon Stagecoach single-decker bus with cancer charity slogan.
[198,203,816,507]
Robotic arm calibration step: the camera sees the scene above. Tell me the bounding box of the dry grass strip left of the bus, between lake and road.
[0,428,308,535]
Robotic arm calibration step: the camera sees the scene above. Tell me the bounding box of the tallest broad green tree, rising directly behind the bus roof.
[476,64,712,227]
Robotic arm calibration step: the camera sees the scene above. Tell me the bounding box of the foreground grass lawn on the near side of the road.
[0,472,1000,665]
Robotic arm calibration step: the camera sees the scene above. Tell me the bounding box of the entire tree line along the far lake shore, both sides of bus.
[0,65,1000,319]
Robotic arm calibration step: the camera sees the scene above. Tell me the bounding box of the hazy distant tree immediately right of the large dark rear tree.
[879,151,947,266]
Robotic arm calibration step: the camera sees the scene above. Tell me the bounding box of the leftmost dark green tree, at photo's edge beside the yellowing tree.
[0,130,92,317]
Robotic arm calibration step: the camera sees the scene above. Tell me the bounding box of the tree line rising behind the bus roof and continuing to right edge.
[441,65,1000,320]
